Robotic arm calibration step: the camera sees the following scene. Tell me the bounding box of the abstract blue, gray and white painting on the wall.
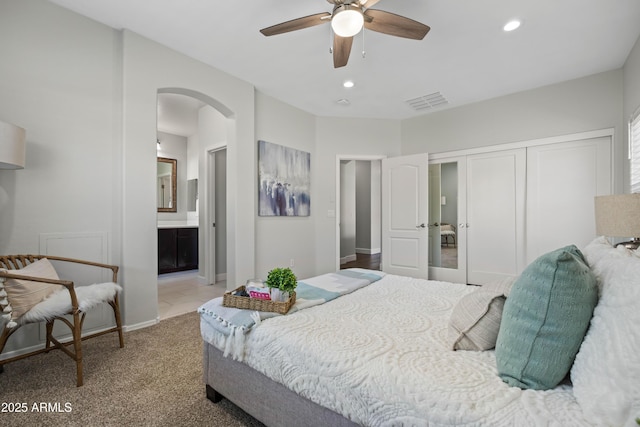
[258,141,311,216]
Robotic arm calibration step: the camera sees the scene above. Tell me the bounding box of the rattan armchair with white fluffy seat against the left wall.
[0,255,124,387]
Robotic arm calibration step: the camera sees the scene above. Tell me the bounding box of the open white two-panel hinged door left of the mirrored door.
[382,153,429,279]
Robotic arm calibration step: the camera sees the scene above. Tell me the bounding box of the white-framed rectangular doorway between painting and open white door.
[336,155,383,270]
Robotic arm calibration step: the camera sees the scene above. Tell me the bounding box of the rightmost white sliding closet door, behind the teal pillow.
[527,136,612,262]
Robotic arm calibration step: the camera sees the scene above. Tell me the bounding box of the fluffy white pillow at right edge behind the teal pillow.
[571,237,640,426]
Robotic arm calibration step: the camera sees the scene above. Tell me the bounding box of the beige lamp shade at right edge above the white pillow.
[595,193,640,237]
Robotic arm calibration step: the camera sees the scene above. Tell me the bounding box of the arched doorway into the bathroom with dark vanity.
[157,91,227,320]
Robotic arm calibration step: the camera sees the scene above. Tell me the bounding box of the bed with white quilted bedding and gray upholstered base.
[199,238,640,426]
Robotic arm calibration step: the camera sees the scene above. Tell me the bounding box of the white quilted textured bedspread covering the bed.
[203,275,590,427]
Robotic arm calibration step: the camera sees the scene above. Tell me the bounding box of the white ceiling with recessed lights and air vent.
[50,0,640,123]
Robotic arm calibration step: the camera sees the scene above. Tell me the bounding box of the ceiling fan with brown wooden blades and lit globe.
[260,0,430,68]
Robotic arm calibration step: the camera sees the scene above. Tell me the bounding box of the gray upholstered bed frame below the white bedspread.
[203,342,357,427]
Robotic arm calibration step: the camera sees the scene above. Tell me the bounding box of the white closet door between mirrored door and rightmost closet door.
[466,148,526,285]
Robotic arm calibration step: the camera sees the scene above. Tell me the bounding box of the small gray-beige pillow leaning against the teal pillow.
[449,278,515,351]
